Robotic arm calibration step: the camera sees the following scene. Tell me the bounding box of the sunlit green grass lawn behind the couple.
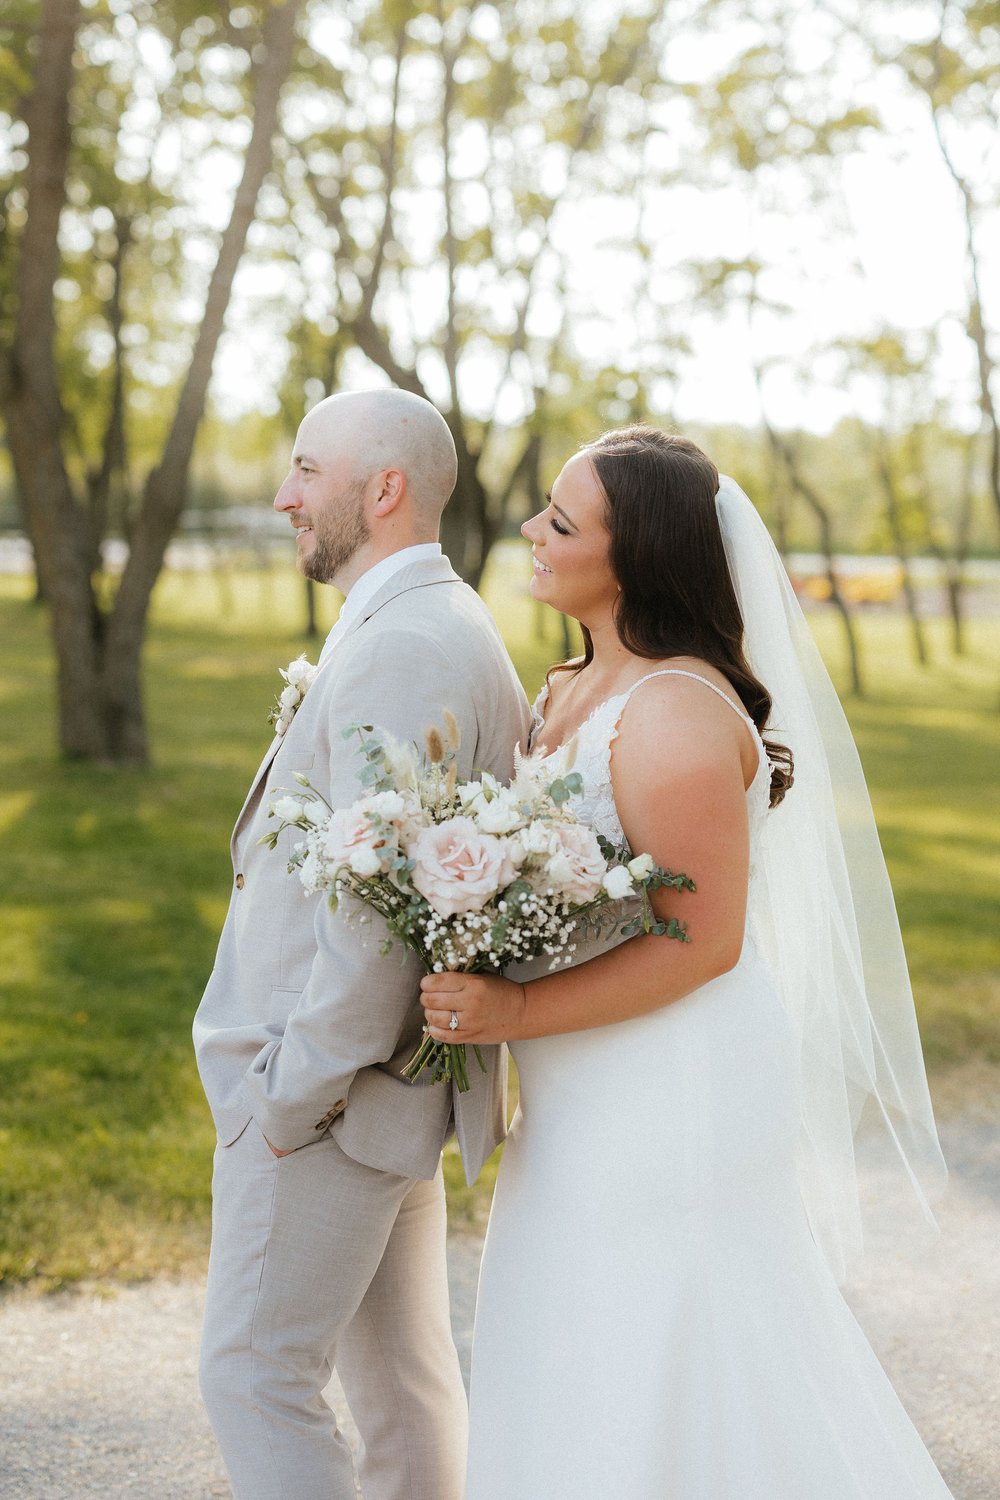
[0,549,1000,1286]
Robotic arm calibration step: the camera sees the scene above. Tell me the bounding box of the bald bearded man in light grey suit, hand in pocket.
[195,390,529,1500]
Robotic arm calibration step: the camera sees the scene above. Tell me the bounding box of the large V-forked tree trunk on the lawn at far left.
[0,0,300,764]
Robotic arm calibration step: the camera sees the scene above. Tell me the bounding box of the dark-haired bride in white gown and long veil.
[423,428,948,1500]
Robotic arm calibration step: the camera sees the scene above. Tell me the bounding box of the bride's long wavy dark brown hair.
[551,426,793,807]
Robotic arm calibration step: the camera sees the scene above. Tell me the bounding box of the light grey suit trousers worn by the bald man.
[201,1121,468,1500]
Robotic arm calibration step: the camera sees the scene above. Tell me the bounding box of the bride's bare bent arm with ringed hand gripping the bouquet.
[421,678,750,1043]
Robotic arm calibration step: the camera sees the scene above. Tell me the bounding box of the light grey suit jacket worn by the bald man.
[193,558,529,1182]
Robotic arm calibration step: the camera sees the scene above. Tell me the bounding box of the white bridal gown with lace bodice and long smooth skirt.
[466,674,949,1500]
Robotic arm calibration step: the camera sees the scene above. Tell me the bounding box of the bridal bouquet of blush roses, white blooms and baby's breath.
[261,711,694,1092]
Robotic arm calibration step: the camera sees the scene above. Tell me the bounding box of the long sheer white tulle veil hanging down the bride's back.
[717,477,946,1280]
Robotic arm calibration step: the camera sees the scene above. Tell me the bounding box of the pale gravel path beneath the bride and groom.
[0,1113,1000,1500]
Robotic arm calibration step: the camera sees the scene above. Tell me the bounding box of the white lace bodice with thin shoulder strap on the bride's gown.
[531,668,771,858]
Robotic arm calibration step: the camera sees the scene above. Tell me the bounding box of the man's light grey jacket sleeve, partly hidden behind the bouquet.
[244,630,478,1151]
